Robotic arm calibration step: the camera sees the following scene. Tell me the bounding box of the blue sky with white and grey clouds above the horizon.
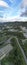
[0,0,27,21]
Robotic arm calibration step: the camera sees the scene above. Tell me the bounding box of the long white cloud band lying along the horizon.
[0,16,27,22]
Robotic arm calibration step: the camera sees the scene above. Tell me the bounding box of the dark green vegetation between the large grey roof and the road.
[1,38,26,65]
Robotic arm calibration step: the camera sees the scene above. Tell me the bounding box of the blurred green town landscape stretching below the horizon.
[0,22,27,65]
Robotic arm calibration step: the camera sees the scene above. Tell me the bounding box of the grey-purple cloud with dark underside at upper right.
[19,0,27,17]
